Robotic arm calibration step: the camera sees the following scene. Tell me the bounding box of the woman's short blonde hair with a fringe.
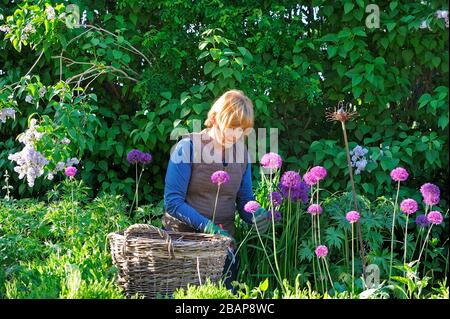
[205,89,254,131]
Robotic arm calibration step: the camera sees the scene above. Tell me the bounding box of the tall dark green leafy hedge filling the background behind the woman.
[0,0,448,202]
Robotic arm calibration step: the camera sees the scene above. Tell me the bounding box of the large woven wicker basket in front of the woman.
[108,224,229,298]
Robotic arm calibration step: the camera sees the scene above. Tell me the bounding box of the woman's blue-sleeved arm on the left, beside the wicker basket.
[164,138,209,231]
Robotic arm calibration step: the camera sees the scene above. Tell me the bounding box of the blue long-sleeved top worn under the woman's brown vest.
[164,137,255,231]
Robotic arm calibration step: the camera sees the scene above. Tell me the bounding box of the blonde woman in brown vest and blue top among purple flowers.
[162,90,269,289]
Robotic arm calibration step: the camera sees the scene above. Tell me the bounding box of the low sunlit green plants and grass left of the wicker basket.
[0,181,165,298]
